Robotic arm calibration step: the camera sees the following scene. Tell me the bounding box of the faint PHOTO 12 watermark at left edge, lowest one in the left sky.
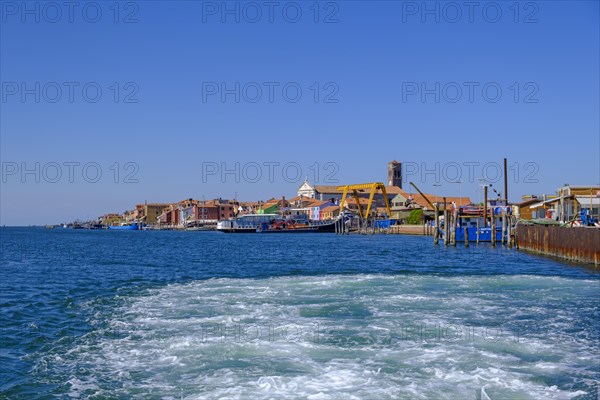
[1,161,140,184]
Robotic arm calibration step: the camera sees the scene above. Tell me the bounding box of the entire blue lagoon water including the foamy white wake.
[0,228,600,400]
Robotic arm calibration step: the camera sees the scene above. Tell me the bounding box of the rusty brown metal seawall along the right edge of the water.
[517,224,600,266]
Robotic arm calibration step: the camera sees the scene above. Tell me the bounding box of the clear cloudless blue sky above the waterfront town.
[0,0,600,225]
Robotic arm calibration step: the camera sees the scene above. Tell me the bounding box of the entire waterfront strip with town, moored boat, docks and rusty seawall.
[47,159,600,265]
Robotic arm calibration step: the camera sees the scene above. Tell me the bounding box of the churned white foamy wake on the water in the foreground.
[39,275,599,399]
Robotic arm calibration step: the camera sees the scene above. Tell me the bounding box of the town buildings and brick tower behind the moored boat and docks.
[65,160,600,230]
